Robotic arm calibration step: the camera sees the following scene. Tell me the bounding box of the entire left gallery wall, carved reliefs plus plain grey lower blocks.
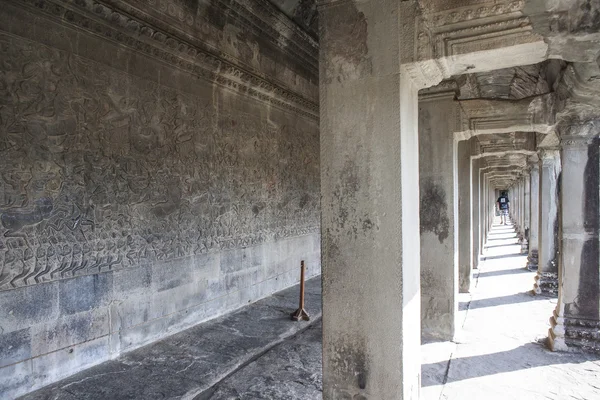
[0,0,320,398]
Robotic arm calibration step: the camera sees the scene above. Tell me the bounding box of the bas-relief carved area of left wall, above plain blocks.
[0,33,319,290]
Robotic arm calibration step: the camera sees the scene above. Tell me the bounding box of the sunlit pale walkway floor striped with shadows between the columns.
[421,225,600,400]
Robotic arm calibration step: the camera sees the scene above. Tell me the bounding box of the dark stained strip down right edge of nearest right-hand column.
[568,138,600,318]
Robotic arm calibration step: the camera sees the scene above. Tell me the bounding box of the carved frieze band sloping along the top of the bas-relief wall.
[8,0,319,119]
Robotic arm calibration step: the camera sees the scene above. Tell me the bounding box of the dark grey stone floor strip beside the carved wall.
[20,278,321,400]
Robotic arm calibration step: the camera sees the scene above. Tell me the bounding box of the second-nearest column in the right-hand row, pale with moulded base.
[533,149,560,296]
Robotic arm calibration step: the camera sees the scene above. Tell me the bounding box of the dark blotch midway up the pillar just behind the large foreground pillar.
[419,178,450,243]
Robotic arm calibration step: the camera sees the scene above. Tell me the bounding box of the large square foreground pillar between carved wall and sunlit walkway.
[319,1,421,400]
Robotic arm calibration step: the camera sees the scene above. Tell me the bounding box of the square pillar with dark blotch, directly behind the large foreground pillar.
[419,91,458,340]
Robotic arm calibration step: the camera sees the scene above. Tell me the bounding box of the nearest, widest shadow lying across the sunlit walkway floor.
[421,343,600,386]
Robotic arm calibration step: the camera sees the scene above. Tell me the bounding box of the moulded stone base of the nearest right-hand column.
[548,310,600,354]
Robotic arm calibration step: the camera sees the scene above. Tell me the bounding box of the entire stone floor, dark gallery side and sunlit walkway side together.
[17,220,600,400]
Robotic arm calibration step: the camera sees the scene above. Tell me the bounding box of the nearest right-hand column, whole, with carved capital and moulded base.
[549,120,600,352]
